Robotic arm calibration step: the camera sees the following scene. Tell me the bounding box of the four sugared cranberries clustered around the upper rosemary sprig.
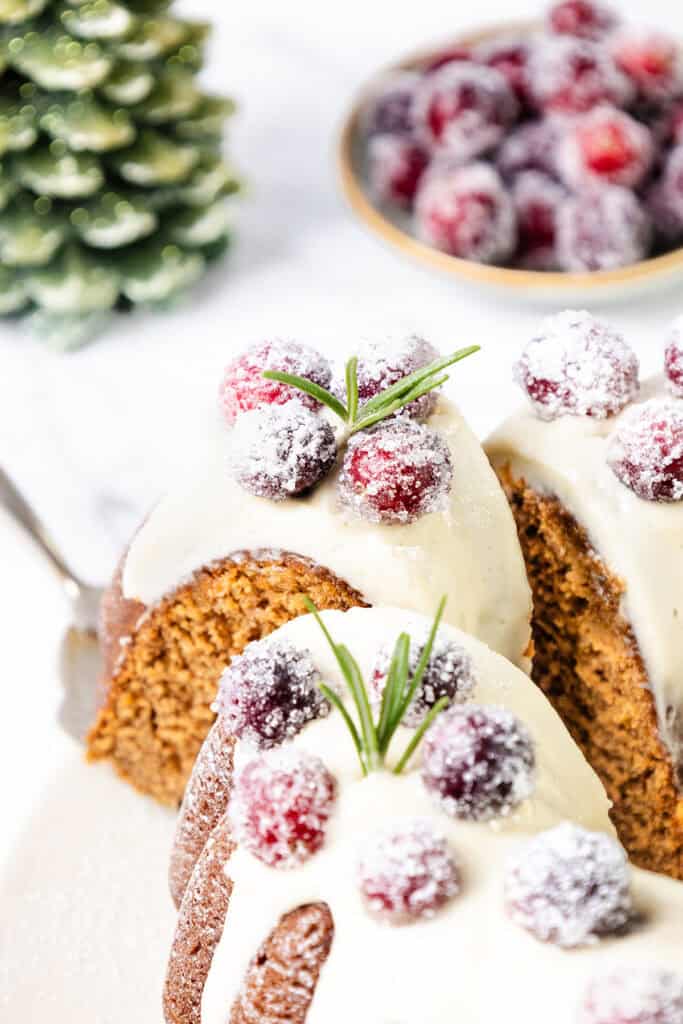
[219,339,453,524]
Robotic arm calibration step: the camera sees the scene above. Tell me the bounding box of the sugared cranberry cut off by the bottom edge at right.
[580,965,683,1024]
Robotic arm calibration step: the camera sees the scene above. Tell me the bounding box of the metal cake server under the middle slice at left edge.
[0,467,102,742]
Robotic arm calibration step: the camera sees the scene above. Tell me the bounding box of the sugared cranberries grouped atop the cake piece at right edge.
[514,310,683,502]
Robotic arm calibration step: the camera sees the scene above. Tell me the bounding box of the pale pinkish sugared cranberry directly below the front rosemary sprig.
[358,818,460,924]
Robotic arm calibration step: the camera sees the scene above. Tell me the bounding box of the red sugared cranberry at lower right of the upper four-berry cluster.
[339,419,453,524]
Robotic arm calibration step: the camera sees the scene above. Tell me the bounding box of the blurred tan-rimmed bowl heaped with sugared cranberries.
[339,0,683,303]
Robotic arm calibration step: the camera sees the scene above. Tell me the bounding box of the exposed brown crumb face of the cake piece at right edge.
[499,466,683,880]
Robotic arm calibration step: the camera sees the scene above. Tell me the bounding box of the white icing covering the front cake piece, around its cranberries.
[202,608,683,1024]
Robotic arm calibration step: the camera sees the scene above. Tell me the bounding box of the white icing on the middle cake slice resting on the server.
[123,398,531,664]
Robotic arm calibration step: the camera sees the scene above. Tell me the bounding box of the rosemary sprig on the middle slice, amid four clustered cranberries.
[263,345,480,435]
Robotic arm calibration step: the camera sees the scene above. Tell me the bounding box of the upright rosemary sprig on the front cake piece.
[304,597,450,775]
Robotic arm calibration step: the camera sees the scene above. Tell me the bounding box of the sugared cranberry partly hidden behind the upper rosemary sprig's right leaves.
[332,335,439,420]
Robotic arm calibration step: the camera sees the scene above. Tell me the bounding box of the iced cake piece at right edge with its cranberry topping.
[487,311,683,880]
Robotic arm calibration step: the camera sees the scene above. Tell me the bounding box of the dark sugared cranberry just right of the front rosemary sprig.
[422,705,536,821]
